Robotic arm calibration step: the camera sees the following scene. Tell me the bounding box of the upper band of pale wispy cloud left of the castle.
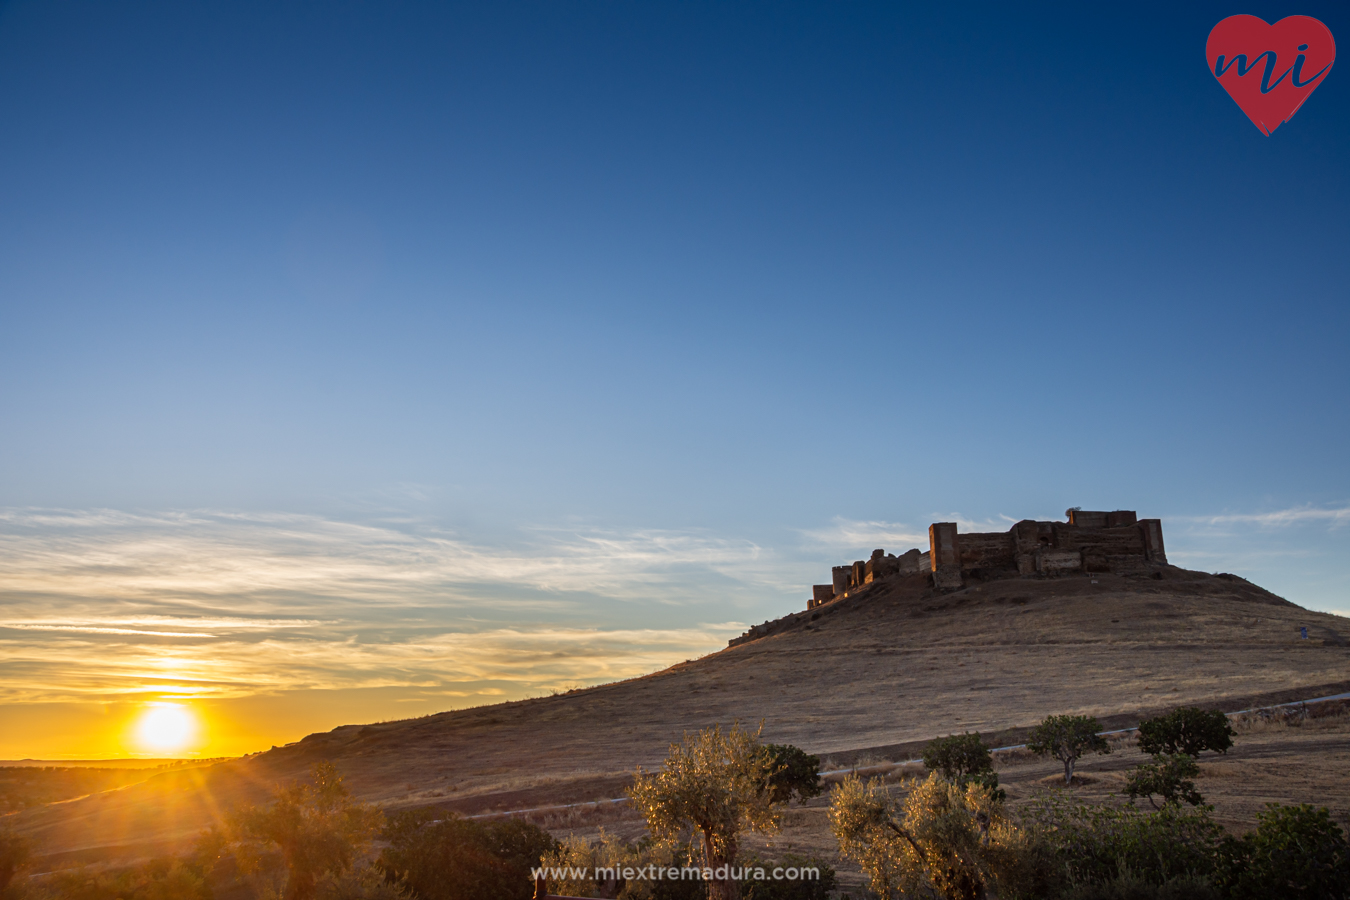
[0,510,771,604]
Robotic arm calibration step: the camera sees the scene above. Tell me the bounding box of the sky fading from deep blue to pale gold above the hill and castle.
[0,3,1350,752]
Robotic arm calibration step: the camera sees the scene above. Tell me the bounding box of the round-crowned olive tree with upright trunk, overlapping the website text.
[628,725,782,900]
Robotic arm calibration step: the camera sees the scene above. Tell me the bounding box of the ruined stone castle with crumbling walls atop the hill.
[806,509,1168,610]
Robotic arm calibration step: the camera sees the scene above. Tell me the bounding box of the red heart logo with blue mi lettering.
[1204,16,1337,135]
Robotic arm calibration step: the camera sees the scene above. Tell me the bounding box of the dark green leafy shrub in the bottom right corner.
[1219,803,1350,900]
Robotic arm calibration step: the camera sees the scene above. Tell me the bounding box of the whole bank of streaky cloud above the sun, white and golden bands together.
[0,510,783,703]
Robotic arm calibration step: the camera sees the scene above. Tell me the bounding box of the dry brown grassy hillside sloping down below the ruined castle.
[16,568,1350,851]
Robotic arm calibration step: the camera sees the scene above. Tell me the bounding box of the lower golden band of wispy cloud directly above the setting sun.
[0,622,744,703]
